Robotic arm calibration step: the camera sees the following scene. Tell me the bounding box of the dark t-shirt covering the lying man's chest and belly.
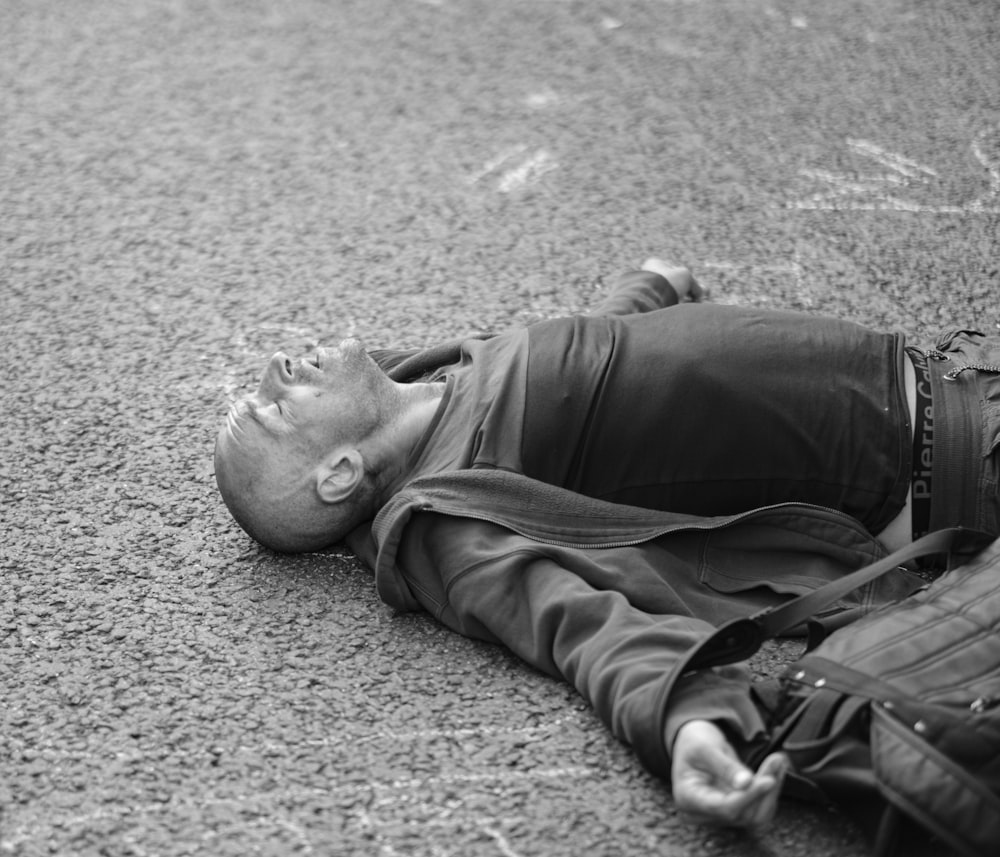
[404,304,910,532]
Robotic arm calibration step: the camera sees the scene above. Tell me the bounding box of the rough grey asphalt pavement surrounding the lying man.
[0,0,1000,857]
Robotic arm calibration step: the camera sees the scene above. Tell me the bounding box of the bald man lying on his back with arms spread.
[215,259,1000,827]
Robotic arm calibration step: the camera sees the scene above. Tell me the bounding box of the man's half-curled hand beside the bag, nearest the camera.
[670,720,788,832]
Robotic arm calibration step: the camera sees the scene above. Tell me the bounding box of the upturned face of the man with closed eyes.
[241,339,393,457]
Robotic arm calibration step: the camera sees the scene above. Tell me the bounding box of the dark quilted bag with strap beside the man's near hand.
[685,530,1000,857]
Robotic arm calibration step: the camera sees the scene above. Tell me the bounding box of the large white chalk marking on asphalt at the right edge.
[787,135,1000,215]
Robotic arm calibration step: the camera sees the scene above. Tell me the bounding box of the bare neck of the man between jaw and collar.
[373,383,444,508]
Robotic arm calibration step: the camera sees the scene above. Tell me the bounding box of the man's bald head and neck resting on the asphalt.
[215,340,442,553]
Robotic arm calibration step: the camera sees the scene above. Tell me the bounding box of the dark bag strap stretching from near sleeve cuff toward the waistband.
[674,527,966,675]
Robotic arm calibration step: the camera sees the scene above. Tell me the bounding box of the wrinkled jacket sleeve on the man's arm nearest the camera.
[392,513,763,779]
